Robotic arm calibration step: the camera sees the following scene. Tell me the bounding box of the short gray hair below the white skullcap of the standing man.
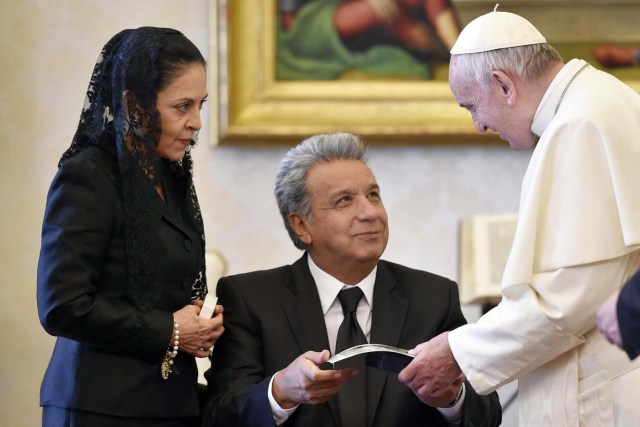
[454,43,562,92]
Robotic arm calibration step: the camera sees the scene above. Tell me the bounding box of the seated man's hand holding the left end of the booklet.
[272,350,358,409]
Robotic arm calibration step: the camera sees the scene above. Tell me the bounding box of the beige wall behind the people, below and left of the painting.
[0,0,530,426]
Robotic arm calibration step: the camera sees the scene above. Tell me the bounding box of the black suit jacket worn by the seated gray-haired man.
[202,255,501,427]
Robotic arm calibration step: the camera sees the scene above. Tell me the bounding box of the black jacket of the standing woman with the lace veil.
[38,148,204,417]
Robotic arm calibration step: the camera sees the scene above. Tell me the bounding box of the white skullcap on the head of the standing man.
[451,4,547,55]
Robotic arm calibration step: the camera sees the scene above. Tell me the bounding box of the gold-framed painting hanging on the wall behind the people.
[209,0,640,146]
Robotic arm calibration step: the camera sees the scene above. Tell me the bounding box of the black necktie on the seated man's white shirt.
[336,286,367,427]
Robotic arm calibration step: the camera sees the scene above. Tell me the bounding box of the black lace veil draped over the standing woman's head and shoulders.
[59,27,207,311]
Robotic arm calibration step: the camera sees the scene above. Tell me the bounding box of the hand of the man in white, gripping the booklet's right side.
[398,332,462,406]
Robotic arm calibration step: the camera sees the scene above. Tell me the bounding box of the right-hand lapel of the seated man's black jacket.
[367,261,409,425]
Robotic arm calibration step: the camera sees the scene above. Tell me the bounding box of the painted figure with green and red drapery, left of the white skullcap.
[276,0,460,80]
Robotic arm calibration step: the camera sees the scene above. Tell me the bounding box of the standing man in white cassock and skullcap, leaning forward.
[399,6,640,427]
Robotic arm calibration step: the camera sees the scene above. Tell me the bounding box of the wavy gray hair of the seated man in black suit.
[274,133,367,249]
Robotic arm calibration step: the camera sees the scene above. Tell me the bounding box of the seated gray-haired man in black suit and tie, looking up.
[202,134,502,427]
